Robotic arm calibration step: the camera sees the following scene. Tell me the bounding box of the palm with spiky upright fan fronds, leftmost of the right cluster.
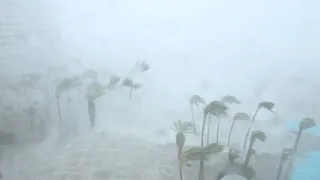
[171,120,194,180]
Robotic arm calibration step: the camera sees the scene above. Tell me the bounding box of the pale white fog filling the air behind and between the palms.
[0,0,320,180]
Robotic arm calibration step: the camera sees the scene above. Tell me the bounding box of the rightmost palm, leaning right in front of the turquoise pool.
[284,117,317,180]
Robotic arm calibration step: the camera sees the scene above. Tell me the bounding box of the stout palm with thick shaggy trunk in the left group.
[87,82,106,128]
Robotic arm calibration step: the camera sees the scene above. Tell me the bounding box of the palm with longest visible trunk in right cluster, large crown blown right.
[199,101,228,180]
